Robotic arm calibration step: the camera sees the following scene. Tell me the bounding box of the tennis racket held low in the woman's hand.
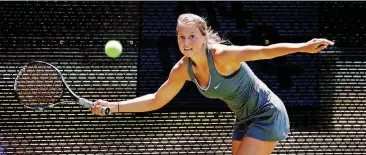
[14,61,110,115]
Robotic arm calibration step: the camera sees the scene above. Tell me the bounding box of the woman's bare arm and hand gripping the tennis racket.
[91,57,189,115]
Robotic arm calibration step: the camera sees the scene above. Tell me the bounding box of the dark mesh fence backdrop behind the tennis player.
[0,1,366,154]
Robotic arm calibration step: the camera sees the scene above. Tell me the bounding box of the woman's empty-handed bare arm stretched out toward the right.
[218,39,334,62]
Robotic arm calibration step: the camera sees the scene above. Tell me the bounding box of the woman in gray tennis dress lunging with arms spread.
[91,14,334,155]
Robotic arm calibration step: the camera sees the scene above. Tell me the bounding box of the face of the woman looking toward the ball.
[177,23,207,57]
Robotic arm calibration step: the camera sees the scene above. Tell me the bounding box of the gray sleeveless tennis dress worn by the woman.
[188,47,290,141]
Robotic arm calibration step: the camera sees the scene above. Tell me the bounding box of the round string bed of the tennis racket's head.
[16,63,63,107]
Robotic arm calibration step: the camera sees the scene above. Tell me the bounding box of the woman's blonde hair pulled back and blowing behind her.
[177,13,229,44]
